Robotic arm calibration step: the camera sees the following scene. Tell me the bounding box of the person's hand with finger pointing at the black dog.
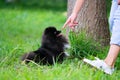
[62,13,78,29]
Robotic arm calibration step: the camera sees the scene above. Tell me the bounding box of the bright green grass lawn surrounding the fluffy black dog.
[0,7,120,80]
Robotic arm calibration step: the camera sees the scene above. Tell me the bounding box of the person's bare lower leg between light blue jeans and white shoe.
[104,44,120,68]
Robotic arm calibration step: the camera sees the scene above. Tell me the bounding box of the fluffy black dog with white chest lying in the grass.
[22,27,69,65]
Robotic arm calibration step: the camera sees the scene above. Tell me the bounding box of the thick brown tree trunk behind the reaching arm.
[67,0,110,46]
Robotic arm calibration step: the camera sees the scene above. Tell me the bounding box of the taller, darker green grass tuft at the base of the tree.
[69,31,104,59]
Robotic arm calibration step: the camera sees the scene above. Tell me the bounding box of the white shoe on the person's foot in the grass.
[83,58,114,75]
